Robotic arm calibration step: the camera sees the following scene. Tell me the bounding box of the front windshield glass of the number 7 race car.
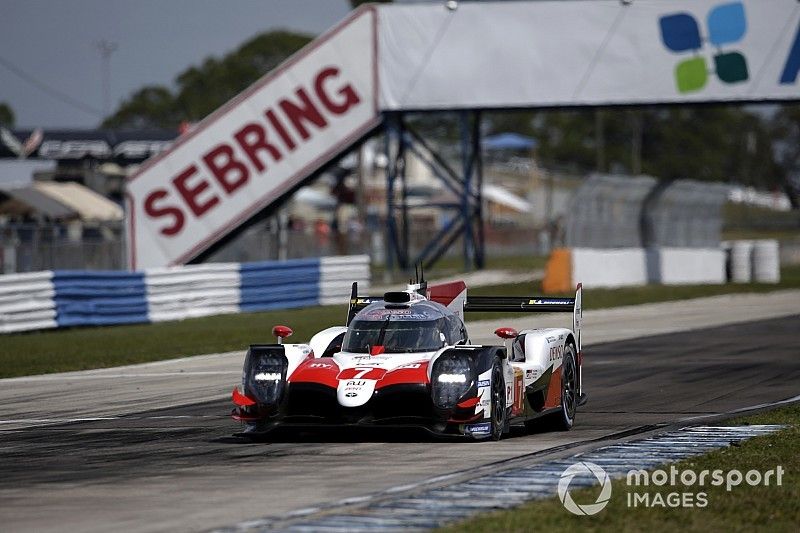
[342,318,444,353]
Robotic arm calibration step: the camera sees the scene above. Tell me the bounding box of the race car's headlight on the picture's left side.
[243,345,289,405]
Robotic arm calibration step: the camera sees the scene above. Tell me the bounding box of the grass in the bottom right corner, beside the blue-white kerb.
[438,404,800,533]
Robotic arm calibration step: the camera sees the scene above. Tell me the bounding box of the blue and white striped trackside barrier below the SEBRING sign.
[0,255,370,333]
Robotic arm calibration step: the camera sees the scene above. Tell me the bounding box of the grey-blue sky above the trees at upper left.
[0,0,350,129]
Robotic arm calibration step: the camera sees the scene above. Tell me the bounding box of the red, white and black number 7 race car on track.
[232,274,586,439]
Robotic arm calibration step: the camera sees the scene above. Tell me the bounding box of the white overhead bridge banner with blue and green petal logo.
[379,0,800,110]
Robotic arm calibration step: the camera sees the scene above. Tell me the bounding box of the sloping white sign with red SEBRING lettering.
[127,10,378,268]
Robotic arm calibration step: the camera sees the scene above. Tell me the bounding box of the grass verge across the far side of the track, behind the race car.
[0,266,800,378]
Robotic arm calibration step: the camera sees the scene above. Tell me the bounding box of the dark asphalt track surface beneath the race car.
[0,316,800,531]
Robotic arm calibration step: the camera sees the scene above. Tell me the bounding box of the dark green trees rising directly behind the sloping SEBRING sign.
[103,30,311,129]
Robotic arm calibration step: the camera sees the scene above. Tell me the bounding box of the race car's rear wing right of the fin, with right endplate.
[464,283,583,352]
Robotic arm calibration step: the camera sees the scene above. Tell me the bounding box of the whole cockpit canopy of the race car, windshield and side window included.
[342,302,467,353]
